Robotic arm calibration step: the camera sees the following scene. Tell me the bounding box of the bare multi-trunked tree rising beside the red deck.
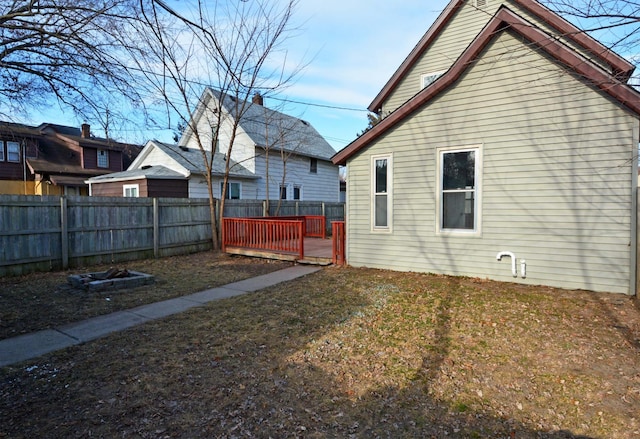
[137,0,297,248]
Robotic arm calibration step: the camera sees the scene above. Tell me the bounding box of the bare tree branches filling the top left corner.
[0,0,144,129]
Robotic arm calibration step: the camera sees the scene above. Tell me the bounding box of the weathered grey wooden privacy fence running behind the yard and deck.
[0,195,344,277]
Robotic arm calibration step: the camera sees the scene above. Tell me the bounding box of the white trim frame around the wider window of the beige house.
[435,144,483,237]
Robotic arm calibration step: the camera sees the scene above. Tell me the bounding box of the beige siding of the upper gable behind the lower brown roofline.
[382,1,624,115]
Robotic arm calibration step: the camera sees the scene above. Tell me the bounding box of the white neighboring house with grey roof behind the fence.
[89,88,340,202]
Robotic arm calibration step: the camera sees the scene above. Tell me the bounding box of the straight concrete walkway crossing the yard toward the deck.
[0,265,321,367]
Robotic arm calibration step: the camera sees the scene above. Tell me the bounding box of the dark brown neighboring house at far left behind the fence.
[0,122,141,195]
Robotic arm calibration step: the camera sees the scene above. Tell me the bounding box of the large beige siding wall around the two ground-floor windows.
[347,29,638,294]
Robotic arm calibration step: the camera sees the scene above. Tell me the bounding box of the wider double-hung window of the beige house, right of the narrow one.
[438,146,482,233]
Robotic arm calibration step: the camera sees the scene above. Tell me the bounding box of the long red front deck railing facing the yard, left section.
[222,218,304,259]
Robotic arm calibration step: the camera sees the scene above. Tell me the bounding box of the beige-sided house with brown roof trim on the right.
[333,0,640,294]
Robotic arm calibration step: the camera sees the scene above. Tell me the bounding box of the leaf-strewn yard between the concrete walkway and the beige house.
[0,268,640,439]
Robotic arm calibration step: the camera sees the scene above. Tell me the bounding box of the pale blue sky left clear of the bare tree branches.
[23,0,448,154]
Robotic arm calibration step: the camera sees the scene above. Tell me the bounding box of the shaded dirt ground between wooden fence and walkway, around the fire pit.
[0,252,291,339]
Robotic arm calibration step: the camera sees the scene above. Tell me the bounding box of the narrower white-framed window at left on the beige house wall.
[371,155,393,232]
